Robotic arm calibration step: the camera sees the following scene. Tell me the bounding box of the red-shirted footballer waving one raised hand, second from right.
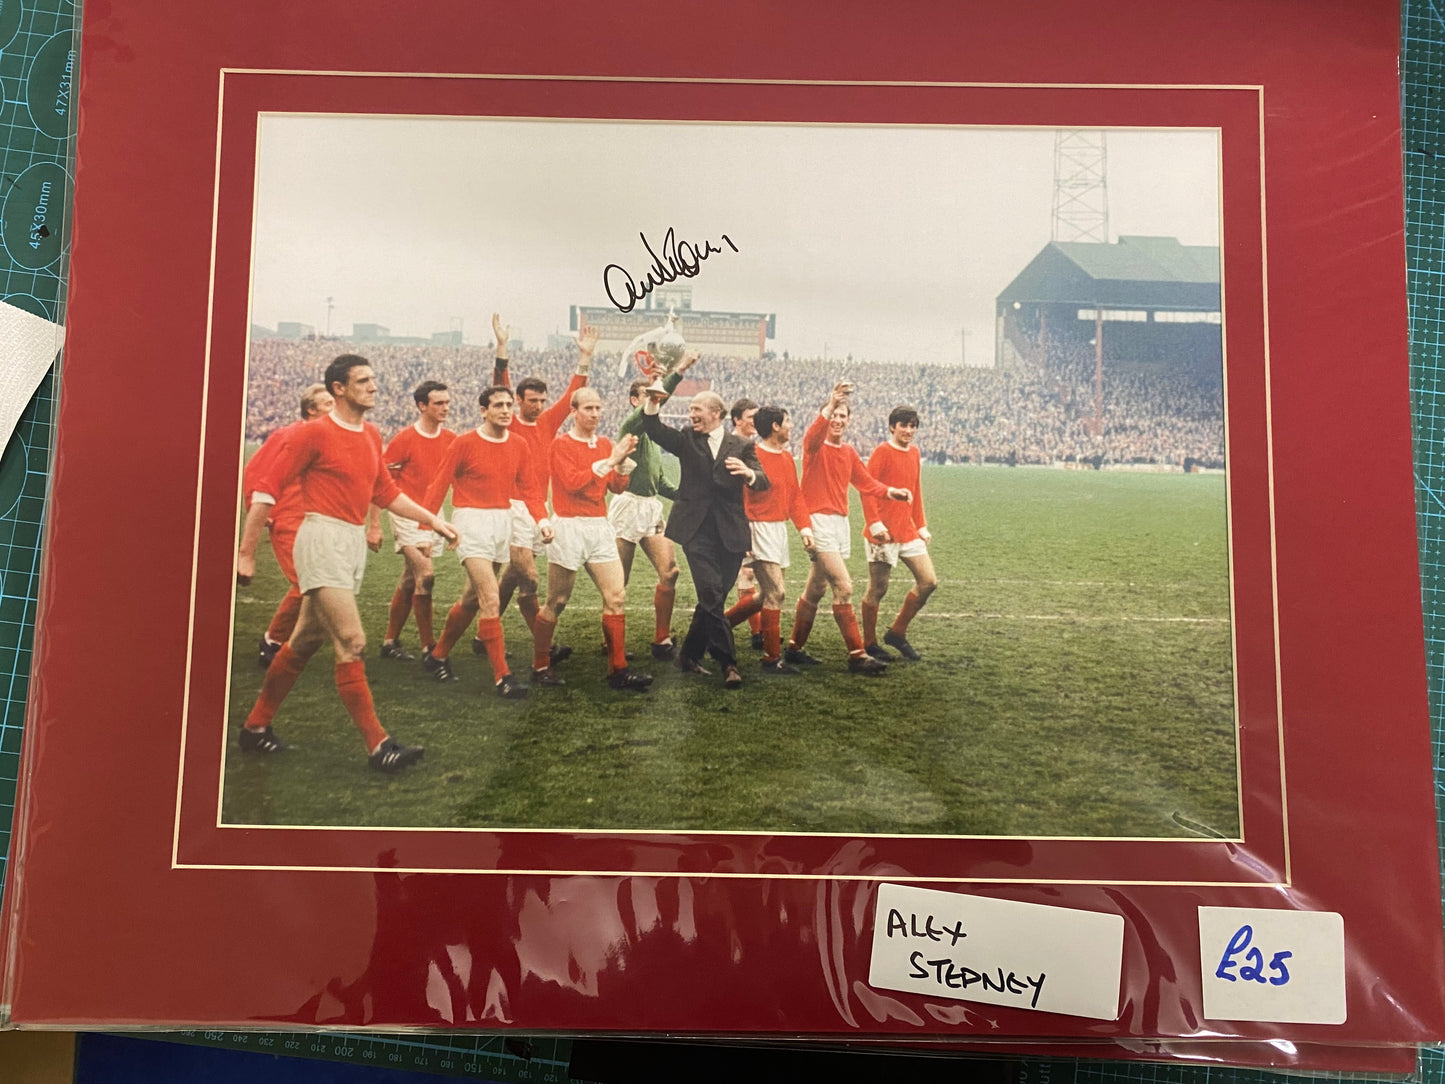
[783,382,913,676]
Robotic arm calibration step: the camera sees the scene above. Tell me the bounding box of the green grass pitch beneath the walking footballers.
[217,467,1238,837]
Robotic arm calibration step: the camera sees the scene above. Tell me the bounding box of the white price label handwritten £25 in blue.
[1199,908,1345,1023]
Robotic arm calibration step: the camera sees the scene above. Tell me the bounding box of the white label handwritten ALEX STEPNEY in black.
[868,885,1124,1020]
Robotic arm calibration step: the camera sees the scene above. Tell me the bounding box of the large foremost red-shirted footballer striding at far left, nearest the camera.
[237,361,457,772]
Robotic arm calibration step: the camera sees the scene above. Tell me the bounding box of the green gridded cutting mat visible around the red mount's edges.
[0,0,1445,1084]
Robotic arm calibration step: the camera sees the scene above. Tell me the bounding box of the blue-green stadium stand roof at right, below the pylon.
[998,237,1220,312]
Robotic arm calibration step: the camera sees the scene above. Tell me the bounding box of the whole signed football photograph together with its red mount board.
[19,0,1445,1046]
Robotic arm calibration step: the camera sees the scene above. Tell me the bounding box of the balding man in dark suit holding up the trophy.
[643,381,769,689]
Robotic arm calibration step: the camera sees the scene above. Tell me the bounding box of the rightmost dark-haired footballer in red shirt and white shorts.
[863,406,938,662]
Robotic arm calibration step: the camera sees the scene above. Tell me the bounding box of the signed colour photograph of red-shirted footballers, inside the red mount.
[216,114,1243,840]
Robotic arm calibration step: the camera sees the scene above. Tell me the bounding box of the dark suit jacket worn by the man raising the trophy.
[642,413,770,554]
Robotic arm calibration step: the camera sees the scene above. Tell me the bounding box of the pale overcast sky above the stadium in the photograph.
[251,116,1220,363]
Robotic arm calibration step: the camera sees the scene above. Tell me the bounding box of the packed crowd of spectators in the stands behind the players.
[246,338,1224,467]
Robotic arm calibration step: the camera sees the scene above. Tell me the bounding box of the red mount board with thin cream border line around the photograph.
[4,0,1445,1046]
